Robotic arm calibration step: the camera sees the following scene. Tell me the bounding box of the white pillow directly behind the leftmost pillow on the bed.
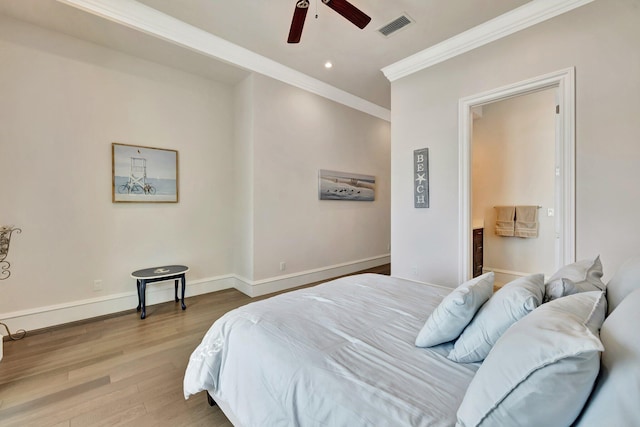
[447,274,544,363]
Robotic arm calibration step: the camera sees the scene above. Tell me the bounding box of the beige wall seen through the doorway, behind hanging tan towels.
[472,89,556,276]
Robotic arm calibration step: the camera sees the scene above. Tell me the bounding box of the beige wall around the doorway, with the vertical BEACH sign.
[391,0,640,286]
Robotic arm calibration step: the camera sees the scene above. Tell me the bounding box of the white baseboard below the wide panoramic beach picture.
[234,254,391,297]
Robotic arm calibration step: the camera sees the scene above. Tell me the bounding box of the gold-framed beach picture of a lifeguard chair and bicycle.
[111,142,178,203]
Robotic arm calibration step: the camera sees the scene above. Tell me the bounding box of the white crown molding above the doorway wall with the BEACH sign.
[382,0,594,82]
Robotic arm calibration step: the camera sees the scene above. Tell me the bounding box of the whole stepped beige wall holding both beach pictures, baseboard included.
[0,17,390,329]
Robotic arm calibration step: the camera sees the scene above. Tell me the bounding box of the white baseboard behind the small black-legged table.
[0,275,235,331]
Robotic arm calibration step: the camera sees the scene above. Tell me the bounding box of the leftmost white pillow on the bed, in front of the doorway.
[416,272,495,347]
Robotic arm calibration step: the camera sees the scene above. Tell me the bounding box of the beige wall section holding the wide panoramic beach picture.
[253,75,391,288]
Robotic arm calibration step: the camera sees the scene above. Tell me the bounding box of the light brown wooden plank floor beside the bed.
[0,265,390,427]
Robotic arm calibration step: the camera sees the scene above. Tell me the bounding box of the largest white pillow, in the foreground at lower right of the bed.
[456,291,604,427]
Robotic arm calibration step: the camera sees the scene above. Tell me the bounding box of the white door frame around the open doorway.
[458,67,576,283]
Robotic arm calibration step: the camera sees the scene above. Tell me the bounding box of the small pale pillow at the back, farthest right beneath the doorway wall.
[545,255,606,302]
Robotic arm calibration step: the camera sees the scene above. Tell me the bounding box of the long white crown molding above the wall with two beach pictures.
[57,0,391,121]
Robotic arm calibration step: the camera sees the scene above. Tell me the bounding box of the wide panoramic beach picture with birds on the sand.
[318,170,376,202]
